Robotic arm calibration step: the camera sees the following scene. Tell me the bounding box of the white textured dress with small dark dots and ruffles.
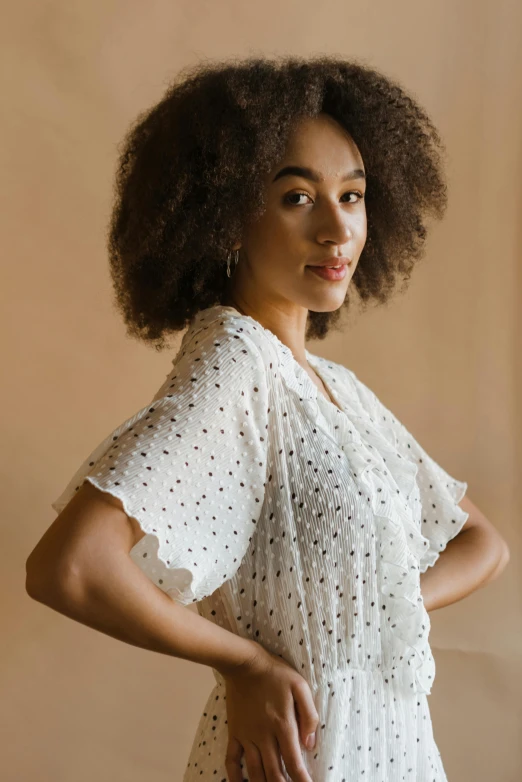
[52,305,468,782]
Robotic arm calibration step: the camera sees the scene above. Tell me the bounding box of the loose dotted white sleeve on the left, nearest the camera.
[52,322,268,604]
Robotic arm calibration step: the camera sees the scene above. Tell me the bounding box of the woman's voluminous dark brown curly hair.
[107,55,447,350]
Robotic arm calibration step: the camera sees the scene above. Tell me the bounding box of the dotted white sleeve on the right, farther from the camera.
[350,370,469,573]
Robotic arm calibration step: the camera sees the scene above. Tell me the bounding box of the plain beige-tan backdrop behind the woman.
[5,0,522,782]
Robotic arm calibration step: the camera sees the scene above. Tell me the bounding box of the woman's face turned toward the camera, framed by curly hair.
[229,114,366,323]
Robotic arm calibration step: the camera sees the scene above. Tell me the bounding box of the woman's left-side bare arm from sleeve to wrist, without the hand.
[26,481,263,675]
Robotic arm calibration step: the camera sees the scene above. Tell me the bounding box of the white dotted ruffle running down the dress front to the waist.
[298,386,435,694]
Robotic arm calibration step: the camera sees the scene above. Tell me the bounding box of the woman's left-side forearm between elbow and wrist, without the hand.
[28,552,259,674]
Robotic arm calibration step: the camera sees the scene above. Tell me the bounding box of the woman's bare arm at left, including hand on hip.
[26,482,319,782]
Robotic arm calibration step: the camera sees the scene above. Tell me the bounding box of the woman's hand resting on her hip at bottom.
[220,645,319,782]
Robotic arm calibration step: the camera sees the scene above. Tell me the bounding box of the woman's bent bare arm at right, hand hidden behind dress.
[420,496,509,611]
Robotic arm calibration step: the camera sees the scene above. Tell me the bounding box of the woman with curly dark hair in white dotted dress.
[27,57,507,782]
